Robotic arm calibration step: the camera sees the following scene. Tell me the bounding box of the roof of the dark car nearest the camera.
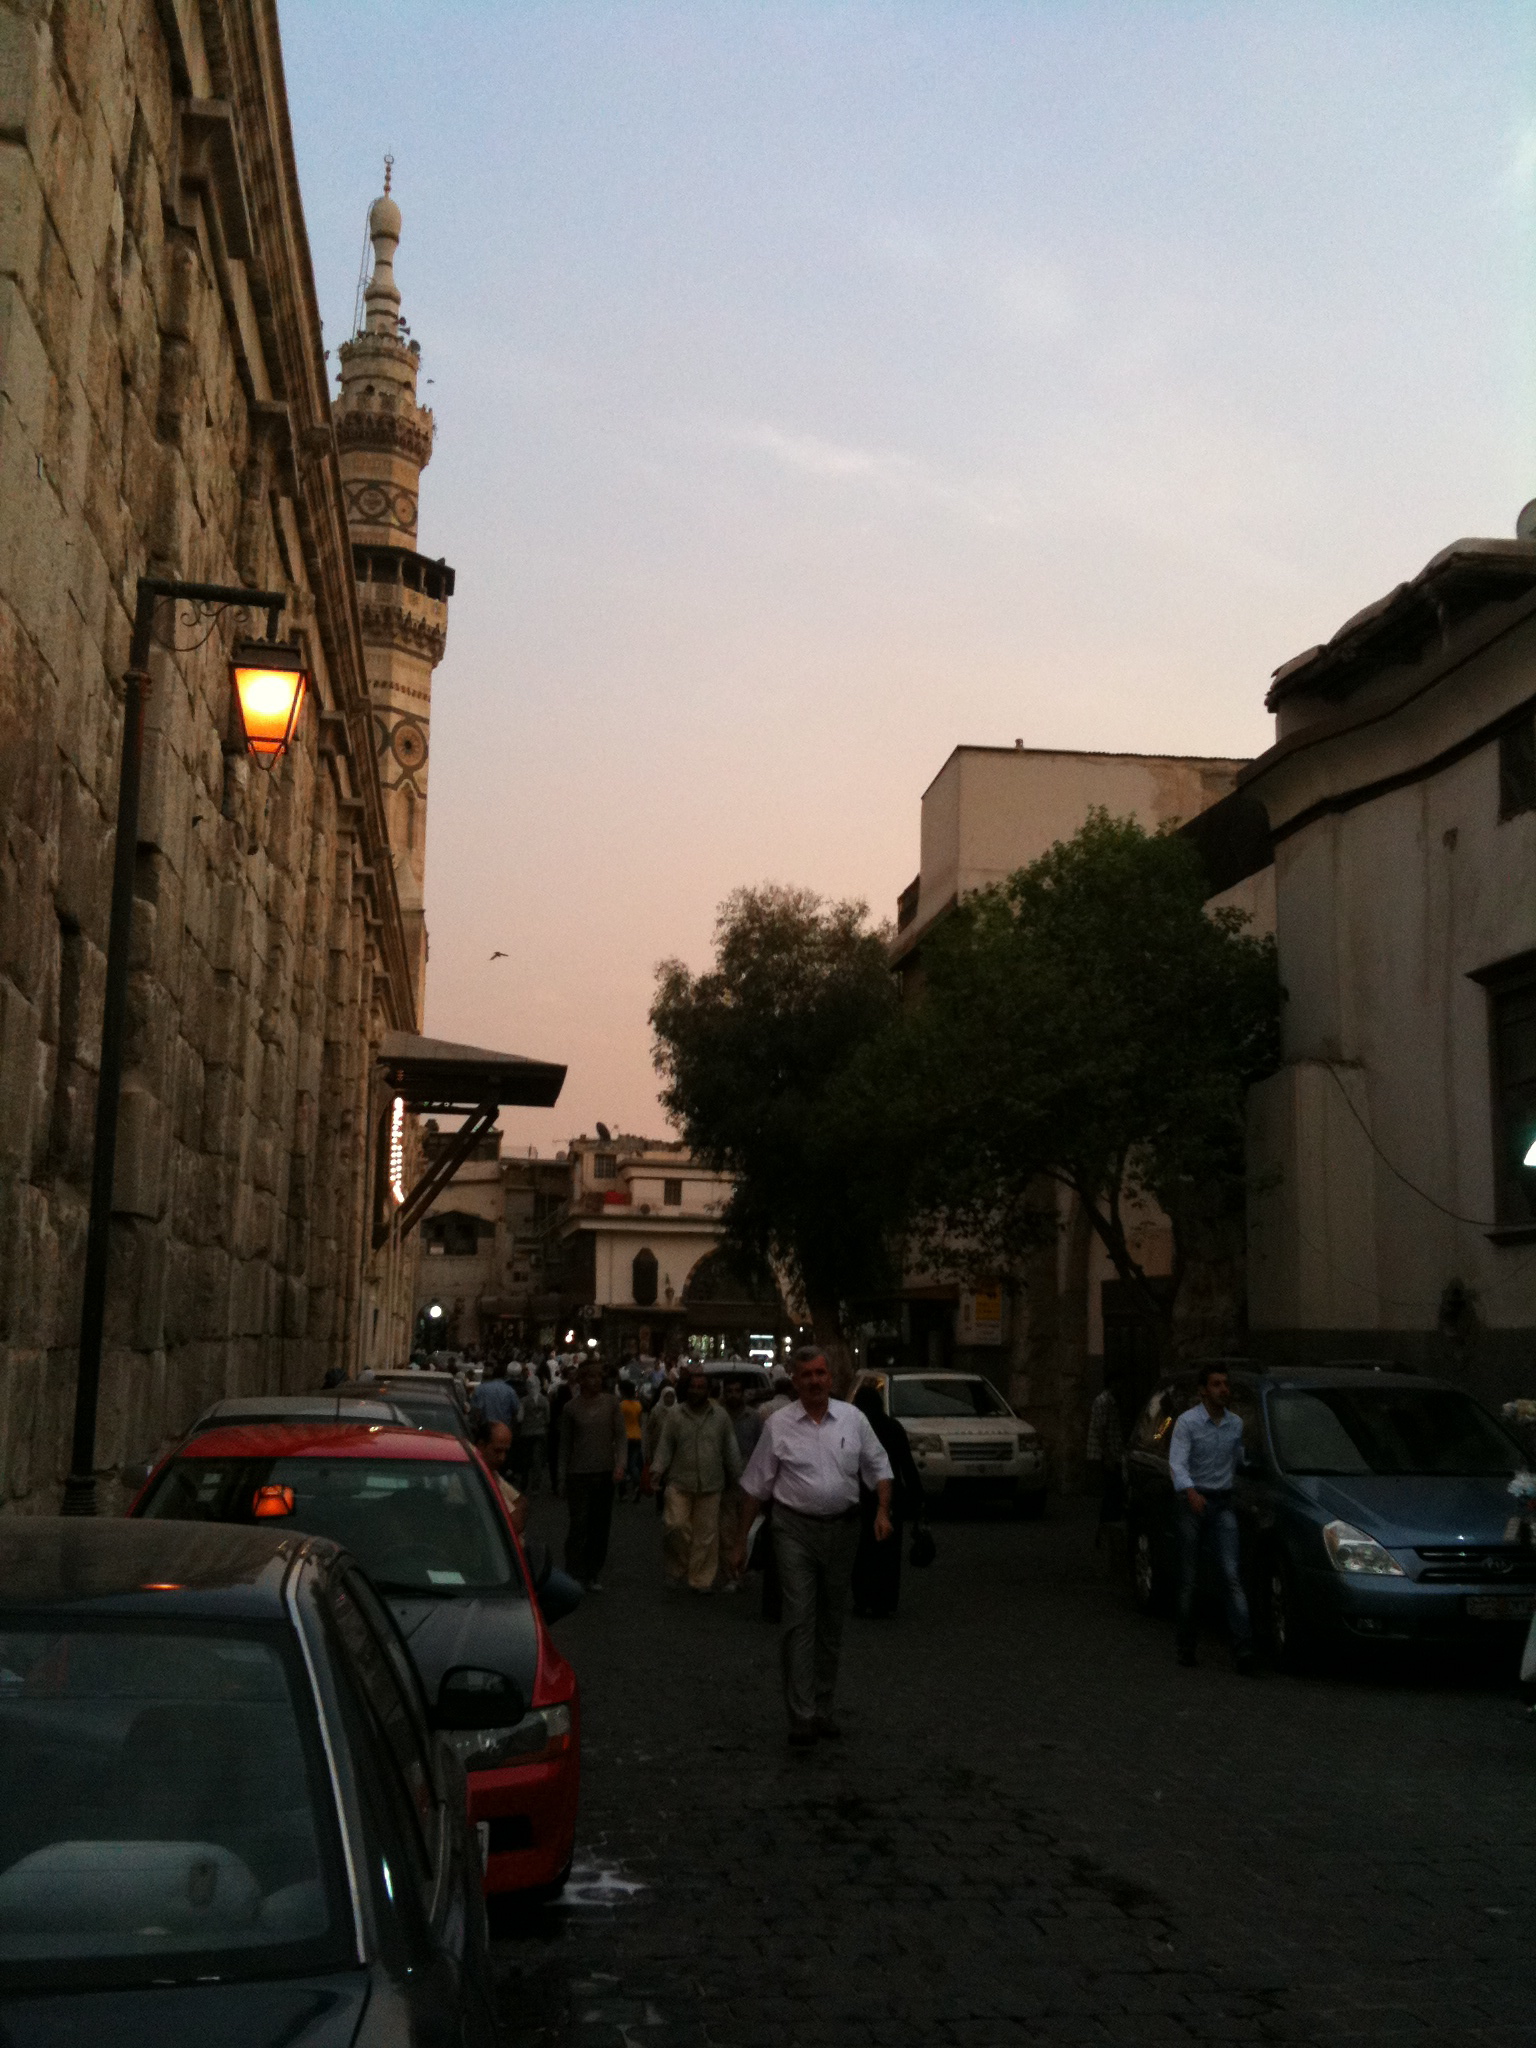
[0,1516,325,1620]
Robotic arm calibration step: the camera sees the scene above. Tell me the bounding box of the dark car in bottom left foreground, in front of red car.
[0,1516,499,2048]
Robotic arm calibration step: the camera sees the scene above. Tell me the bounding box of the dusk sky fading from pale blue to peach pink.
[281,0,1536,1151]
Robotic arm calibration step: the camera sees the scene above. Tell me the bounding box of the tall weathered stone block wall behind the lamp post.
[0,0,416,1511]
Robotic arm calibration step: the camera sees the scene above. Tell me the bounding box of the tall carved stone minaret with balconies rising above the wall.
[334,158,453,1026]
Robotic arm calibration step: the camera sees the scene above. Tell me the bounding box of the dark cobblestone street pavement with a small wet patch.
[496,1501,1536,2048]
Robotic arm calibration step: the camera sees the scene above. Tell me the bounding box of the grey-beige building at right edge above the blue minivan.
[1204,518,1536,1399]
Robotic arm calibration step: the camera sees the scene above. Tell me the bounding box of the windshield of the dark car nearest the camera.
[0,1616,352,1987]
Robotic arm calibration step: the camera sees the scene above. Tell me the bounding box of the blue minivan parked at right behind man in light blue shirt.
[1124,1360,1536,1665]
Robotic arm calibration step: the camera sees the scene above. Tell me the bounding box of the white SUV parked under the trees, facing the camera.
[877,1370,1047,1516]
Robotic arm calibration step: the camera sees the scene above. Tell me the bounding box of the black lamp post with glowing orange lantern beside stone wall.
[63,575,305,1516]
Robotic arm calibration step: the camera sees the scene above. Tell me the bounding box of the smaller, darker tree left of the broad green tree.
[651,887,897,1374]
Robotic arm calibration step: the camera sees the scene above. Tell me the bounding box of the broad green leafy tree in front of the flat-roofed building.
[888,811,1280,1348]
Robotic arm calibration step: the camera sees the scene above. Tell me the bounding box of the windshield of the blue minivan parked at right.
[1270,1386,1526,1479]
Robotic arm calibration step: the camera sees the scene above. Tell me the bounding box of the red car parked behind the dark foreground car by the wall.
[129,1423,582,1896]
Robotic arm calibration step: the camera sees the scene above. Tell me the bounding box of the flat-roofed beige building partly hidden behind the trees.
[891,743,1274,1481]
